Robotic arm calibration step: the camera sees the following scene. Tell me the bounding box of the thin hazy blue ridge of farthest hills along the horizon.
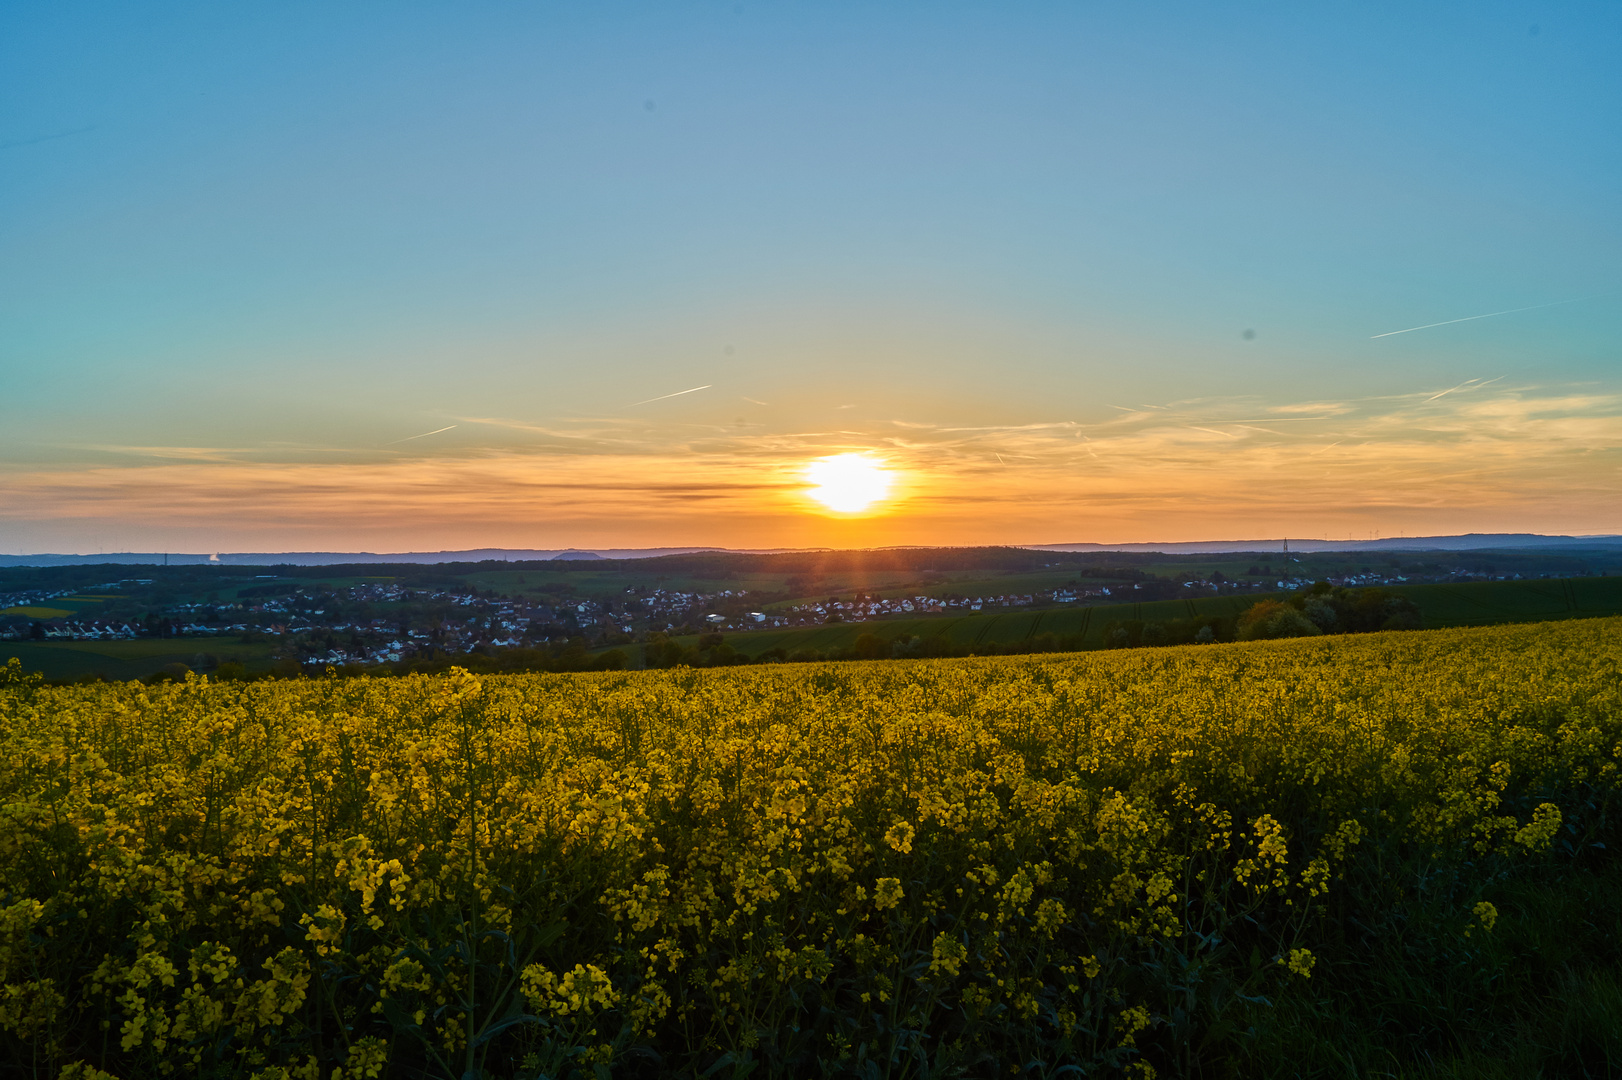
[0,532,1622,566]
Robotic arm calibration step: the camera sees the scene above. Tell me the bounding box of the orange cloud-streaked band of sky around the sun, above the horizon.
[0,383,1622,555]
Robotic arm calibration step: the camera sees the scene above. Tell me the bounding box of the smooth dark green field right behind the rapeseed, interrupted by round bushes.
[680,577,1622,657]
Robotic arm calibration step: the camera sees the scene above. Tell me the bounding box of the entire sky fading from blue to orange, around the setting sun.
[0,0,1622,555]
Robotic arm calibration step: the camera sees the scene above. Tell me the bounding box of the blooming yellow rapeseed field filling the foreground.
[0,619,1622,1080]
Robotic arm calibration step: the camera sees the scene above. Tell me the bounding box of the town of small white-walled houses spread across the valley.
[0,564,1572,665]
